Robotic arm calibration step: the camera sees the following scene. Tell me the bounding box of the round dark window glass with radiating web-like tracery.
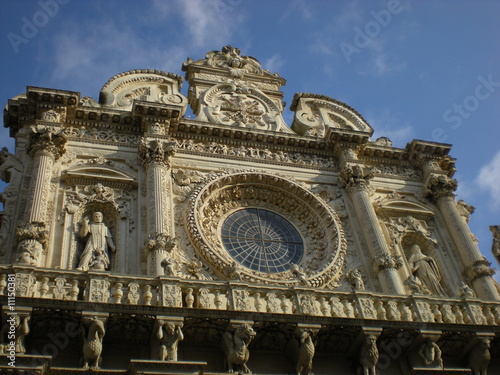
[221,208,304,273]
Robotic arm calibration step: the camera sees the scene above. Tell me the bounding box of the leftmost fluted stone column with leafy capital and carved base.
[16,128,67,266]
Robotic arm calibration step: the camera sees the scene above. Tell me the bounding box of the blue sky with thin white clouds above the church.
[0,0,500,279]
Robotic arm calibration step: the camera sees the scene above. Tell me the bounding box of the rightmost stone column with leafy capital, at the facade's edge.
[424,173,500,301]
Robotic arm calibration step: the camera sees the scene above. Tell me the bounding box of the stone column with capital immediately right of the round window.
[339,164,406,294]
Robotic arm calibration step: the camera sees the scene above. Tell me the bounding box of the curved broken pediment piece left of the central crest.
[99,69,187,114]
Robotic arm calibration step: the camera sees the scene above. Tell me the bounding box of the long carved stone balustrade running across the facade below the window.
[0,266,500,325]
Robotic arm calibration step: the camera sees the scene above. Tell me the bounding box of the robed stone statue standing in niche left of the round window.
[77,211,116,271]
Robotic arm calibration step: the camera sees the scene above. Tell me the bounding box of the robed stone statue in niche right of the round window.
[408,245,446,296]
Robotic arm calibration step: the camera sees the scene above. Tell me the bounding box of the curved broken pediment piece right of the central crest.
[290,93,373,137]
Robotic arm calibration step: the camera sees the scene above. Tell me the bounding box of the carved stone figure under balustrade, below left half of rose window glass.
[222,324,255,374]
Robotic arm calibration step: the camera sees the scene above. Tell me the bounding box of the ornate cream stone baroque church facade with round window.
[0,46,500,375]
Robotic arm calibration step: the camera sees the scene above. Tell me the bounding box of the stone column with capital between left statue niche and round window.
[139,137,176,276]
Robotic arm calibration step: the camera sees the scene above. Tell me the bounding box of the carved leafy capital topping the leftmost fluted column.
[28,127,68,160]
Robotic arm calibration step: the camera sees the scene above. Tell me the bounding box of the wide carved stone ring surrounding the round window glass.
[186,172,347,287]
